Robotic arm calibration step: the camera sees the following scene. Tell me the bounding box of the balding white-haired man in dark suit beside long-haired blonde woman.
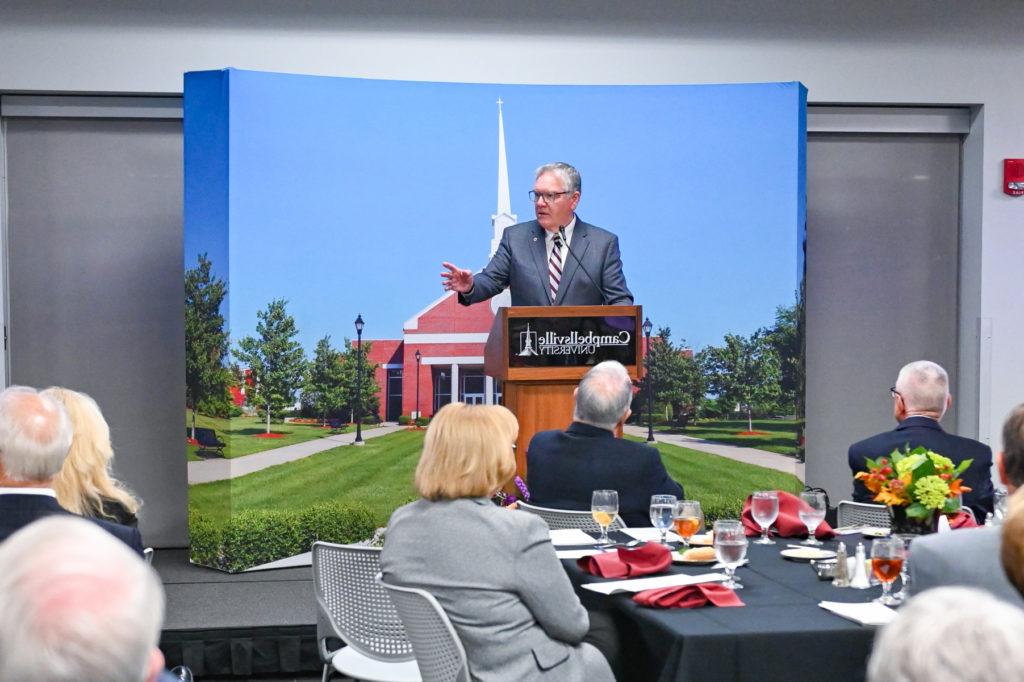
[0,386,143,556]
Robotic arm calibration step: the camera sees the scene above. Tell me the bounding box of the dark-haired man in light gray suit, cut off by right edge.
[910,404,1024,606]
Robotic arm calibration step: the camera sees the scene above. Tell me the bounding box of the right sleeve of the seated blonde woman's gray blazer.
[512,511,590,644]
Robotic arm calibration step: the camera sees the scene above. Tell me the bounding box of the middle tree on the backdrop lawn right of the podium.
[698,330,780,431]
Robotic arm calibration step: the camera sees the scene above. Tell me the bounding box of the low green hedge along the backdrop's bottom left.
[188,502,376,572]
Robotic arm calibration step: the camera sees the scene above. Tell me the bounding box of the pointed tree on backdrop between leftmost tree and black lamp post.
[232,298,306,433]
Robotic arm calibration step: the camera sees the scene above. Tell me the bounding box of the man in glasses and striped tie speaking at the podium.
[441,163,633,305]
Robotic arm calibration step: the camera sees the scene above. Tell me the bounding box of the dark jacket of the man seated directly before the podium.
[526,422,683,526]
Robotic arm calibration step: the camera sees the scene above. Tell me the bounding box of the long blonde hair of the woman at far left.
[43,386,140,518]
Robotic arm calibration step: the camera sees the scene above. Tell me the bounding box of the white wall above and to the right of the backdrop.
[0,0,1024,456]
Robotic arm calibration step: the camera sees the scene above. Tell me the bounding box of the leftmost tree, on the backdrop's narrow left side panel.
[185,254,231,438]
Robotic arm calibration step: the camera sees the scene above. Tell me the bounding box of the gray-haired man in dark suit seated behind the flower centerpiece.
[848,360,993,521]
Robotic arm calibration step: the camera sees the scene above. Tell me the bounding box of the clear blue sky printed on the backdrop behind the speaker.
[185,70,804,352]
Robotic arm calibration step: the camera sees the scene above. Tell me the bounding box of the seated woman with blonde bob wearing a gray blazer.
[381,402,614,682]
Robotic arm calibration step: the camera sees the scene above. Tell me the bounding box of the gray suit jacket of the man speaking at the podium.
[459,217,633,305]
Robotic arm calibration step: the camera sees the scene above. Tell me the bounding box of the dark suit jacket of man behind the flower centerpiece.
[848,417,993,522]
